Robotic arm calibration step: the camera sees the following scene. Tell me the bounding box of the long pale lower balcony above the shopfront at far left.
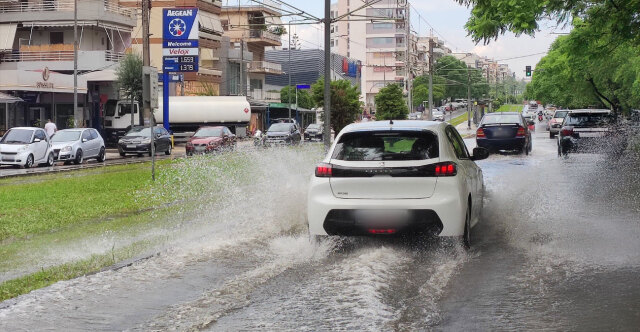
[0,48,125,71]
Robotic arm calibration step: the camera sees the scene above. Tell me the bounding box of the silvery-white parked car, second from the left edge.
[51,128,106,164]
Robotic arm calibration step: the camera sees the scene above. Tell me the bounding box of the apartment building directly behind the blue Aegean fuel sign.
[120,0,223,95]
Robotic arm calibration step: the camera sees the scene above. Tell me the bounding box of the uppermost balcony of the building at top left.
[0,0,136,30]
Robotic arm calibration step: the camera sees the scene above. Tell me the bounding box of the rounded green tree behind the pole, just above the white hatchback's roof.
[311,78,362,133]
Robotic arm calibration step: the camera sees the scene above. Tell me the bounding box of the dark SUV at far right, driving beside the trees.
[558,109,627,156]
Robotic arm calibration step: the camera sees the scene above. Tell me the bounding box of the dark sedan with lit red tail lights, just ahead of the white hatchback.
[476,112,532,155]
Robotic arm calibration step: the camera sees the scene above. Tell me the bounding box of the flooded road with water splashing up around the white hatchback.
[0,123,640,331]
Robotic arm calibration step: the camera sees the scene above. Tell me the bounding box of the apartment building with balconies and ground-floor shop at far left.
[0,0,136,131]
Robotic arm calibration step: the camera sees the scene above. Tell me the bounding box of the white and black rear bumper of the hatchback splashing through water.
[307,177,466,236]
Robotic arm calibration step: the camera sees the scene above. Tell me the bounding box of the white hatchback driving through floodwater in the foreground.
[307,120,488,248]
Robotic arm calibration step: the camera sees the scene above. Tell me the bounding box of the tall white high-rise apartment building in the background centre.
[330,0,417,111]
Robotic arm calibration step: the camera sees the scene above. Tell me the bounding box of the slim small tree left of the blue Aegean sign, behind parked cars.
[116,53,142,126]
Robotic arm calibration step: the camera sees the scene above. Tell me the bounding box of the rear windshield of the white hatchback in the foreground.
[332,130,439,161]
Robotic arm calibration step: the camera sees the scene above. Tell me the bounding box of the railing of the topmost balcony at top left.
[0,0,136,18]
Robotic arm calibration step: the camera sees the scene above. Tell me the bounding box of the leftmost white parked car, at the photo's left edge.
[0,127,54,168]
